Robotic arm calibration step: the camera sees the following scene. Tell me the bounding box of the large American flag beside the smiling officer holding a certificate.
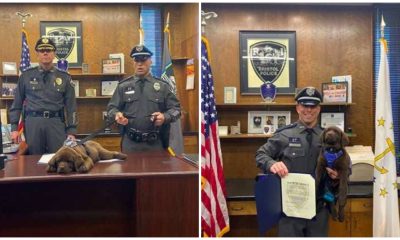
[201,37,229,237]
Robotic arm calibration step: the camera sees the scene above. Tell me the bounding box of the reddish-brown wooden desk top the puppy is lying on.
[0,151,199,184]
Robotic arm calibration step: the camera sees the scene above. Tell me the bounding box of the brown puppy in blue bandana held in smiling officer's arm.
[315,127,351,222]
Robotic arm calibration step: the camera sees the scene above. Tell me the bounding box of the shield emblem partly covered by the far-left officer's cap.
[47,27,76,59]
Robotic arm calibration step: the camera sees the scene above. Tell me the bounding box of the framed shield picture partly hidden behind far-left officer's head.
[40,21,83,68]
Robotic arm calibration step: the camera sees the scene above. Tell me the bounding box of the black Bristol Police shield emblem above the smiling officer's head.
[249,41,287,83]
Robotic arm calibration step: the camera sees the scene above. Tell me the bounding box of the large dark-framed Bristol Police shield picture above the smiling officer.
[239,31,296,95]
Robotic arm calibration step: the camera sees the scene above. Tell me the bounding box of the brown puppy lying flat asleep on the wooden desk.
[47,139,127,173]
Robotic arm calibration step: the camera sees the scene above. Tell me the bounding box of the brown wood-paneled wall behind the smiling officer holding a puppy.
[202,4,374,145]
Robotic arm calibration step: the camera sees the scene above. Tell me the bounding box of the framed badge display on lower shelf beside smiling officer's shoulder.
[247,111,290,134]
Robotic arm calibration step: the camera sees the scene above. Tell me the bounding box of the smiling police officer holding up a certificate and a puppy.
[256,87,338,237]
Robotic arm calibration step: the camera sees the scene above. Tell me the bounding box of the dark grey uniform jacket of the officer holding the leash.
[107,74,181,151]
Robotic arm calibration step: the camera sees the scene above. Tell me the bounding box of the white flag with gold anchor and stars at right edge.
[373,17,400,237]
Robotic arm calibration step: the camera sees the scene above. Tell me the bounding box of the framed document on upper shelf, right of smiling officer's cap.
[322,82,348,103]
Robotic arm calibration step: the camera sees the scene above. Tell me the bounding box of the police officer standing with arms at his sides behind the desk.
[10,37,77,154]
